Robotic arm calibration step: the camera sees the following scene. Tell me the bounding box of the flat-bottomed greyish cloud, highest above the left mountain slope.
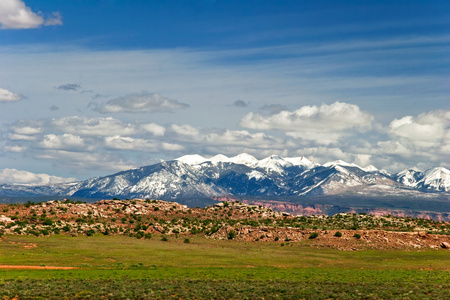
[95,92,189,113]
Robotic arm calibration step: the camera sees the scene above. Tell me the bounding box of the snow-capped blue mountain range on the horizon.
[0,153,450,200]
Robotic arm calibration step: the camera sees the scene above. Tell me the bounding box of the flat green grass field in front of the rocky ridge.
[0,235,450,299]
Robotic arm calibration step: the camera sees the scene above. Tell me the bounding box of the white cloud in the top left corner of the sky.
[0,0,62,29]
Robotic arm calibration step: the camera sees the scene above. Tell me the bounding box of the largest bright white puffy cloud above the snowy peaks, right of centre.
[240,102,373,144]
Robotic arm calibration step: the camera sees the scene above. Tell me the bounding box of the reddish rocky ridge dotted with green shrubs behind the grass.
[0,199,450,250]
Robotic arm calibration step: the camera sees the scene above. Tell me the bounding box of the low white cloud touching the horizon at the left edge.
[0,169,76,185]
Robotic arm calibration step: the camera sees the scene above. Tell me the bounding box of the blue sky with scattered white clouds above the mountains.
[0,0,450,183]
